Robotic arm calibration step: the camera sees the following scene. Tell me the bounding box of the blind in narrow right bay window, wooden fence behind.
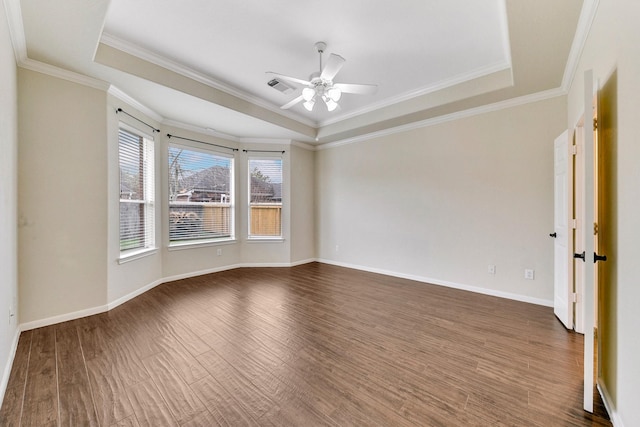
[249,158,282,238]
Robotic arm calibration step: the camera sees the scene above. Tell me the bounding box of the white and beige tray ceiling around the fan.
[13,0,582,143]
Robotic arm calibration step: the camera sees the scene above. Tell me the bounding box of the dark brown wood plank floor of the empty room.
[0,263,611,427]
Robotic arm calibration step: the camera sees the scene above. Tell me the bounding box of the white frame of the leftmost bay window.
[118,122,157,262]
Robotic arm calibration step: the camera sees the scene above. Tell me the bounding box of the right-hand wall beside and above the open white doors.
[568,0,640,427]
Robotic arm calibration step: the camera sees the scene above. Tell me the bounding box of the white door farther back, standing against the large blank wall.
[551,131,573,329]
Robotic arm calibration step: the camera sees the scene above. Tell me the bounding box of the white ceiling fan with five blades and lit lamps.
[267,42,378,111]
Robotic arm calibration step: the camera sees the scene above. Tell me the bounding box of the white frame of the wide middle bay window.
[165,142,236,250]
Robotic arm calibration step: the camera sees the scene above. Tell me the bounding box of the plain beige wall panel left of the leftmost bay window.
[18,69,107,323]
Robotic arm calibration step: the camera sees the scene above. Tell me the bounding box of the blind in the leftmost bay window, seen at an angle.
[118,128,155,252]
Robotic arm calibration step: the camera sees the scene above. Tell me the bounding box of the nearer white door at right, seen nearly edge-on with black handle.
[581,70,596,412]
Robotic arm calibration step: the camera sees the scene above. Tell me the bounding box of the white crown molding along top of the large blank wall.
[316,88,567,150]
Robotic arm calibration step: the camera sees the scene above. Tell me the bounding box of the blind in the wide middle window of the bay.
[168,145,234,244]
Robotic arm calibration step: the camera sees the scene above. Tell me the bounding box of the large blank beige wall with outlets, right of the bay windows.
[316,97,566,303]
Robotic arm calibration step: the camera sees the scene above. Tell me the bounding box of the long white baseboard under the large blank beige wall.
[317,259,553,307]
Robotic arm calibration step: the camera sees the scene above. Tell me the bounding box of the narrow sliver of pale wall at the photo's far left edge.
[0,3,18,402]
